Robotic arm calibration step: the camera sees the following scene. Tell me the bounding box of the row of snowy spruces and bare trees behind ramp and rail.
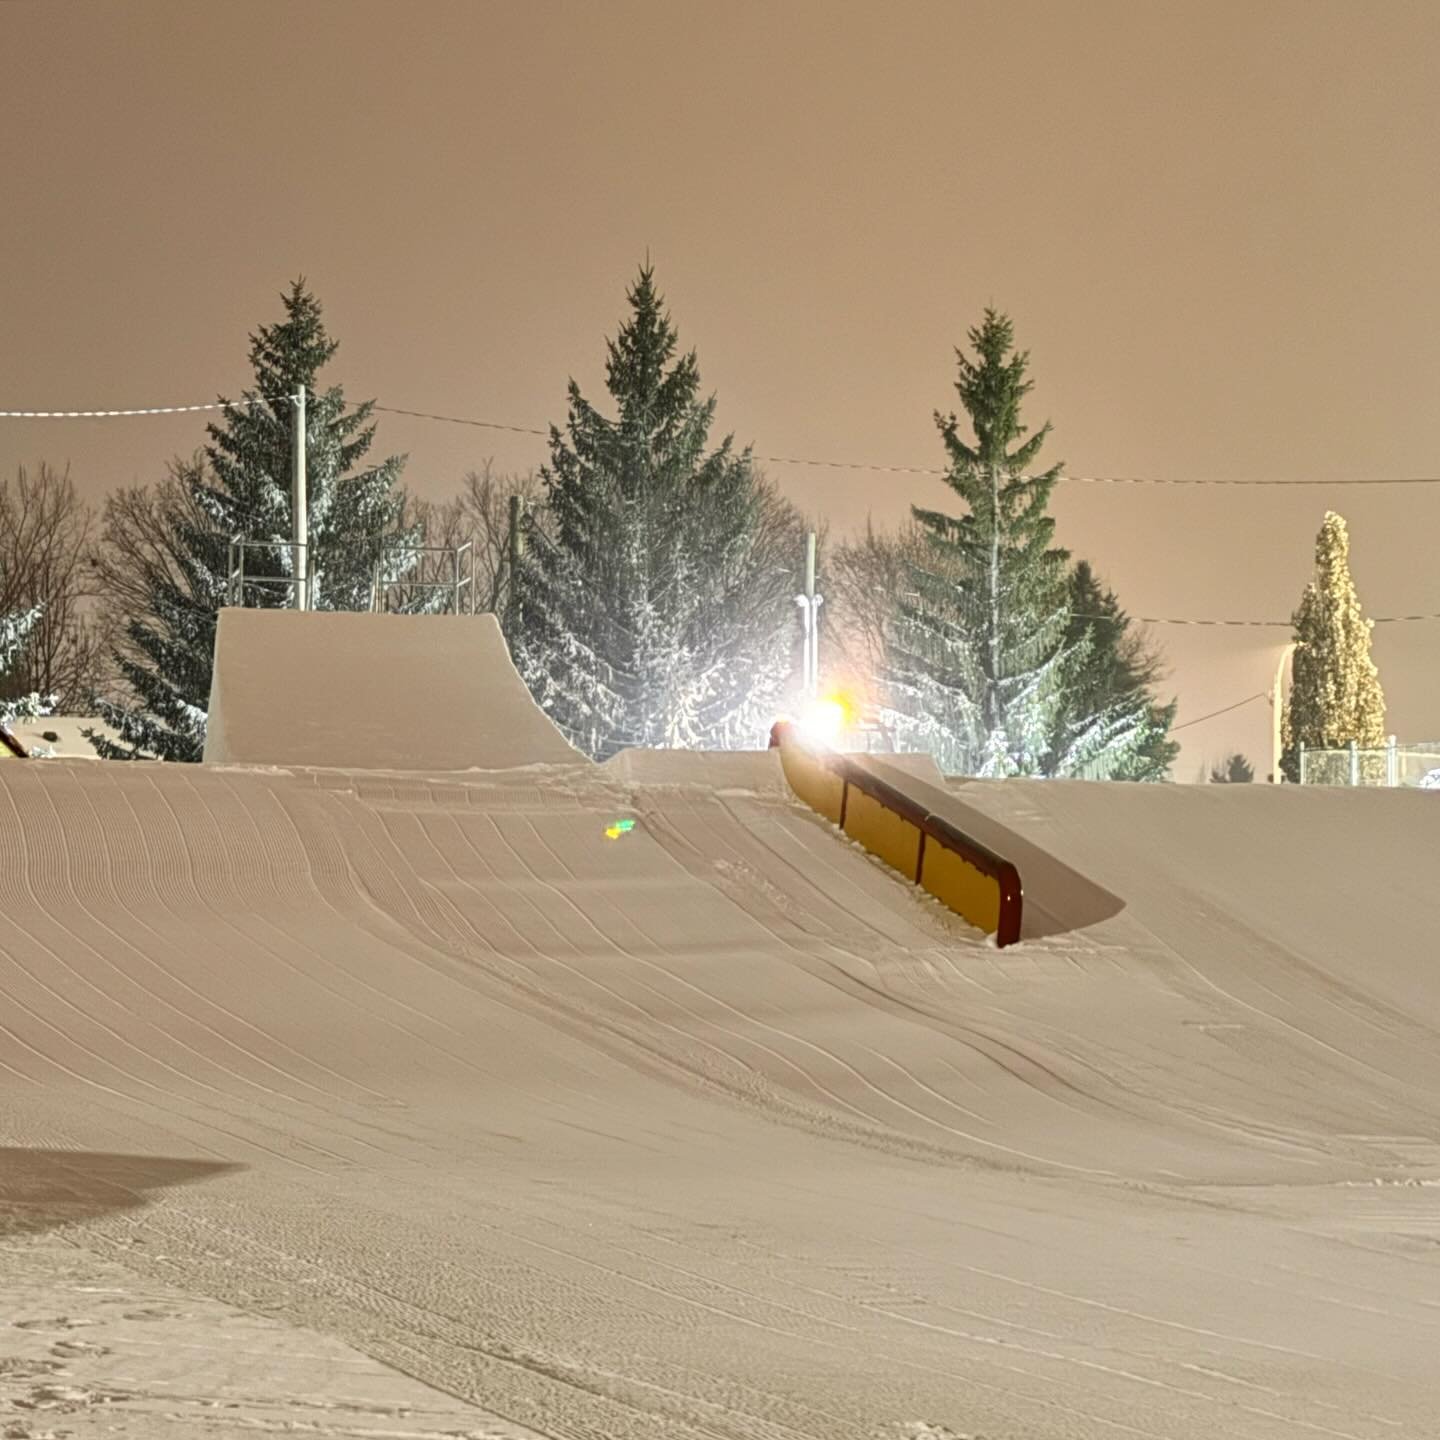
[0,265,1388,780]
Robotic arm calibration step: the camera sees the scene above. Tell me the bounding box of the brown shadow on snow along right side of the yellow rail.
[867,756,1125,940]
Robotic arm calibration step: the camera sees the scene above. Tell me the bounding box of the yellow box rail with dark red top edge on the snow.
[770,720,1024,945]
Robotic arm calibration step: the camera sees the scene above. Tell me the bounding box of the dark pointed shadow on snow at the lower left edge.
[0,1145,245,1240]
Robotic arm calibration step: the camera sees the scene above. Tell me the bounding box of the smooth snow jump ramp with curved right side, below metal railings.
[204,606,585,770]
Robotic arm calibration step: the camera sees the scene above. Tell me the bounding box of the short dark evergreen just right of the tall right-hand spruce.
[1045,560,1179,780]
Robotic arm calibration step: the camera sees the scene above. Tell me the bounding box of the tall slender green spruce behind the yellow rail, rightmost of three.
[883,310,1082,776]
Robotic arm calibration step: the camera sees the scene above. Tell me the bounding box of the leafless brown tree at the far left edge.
[0,461,105,711]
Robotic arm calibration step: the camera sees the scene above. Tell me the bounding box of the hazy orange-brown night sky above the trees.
[0,0,1440,779]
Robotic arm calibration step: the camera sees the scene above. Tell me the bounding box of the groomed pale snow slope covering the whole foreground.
[0,616,1440,1440]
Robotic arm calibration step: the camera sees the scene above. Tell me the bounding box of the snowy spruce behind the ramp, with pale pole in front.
[91,278,415,760]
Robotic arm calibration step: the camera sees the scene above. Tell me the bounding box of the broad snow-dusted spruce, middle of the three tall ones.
[507,265,799,759]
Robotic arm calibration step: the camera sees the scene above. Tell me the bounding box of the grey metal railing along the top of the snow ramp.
[225,536,475,615]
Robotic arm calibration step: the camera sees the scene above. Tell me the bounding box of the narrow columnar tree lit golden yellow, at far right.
[1280,510,1385,782]
